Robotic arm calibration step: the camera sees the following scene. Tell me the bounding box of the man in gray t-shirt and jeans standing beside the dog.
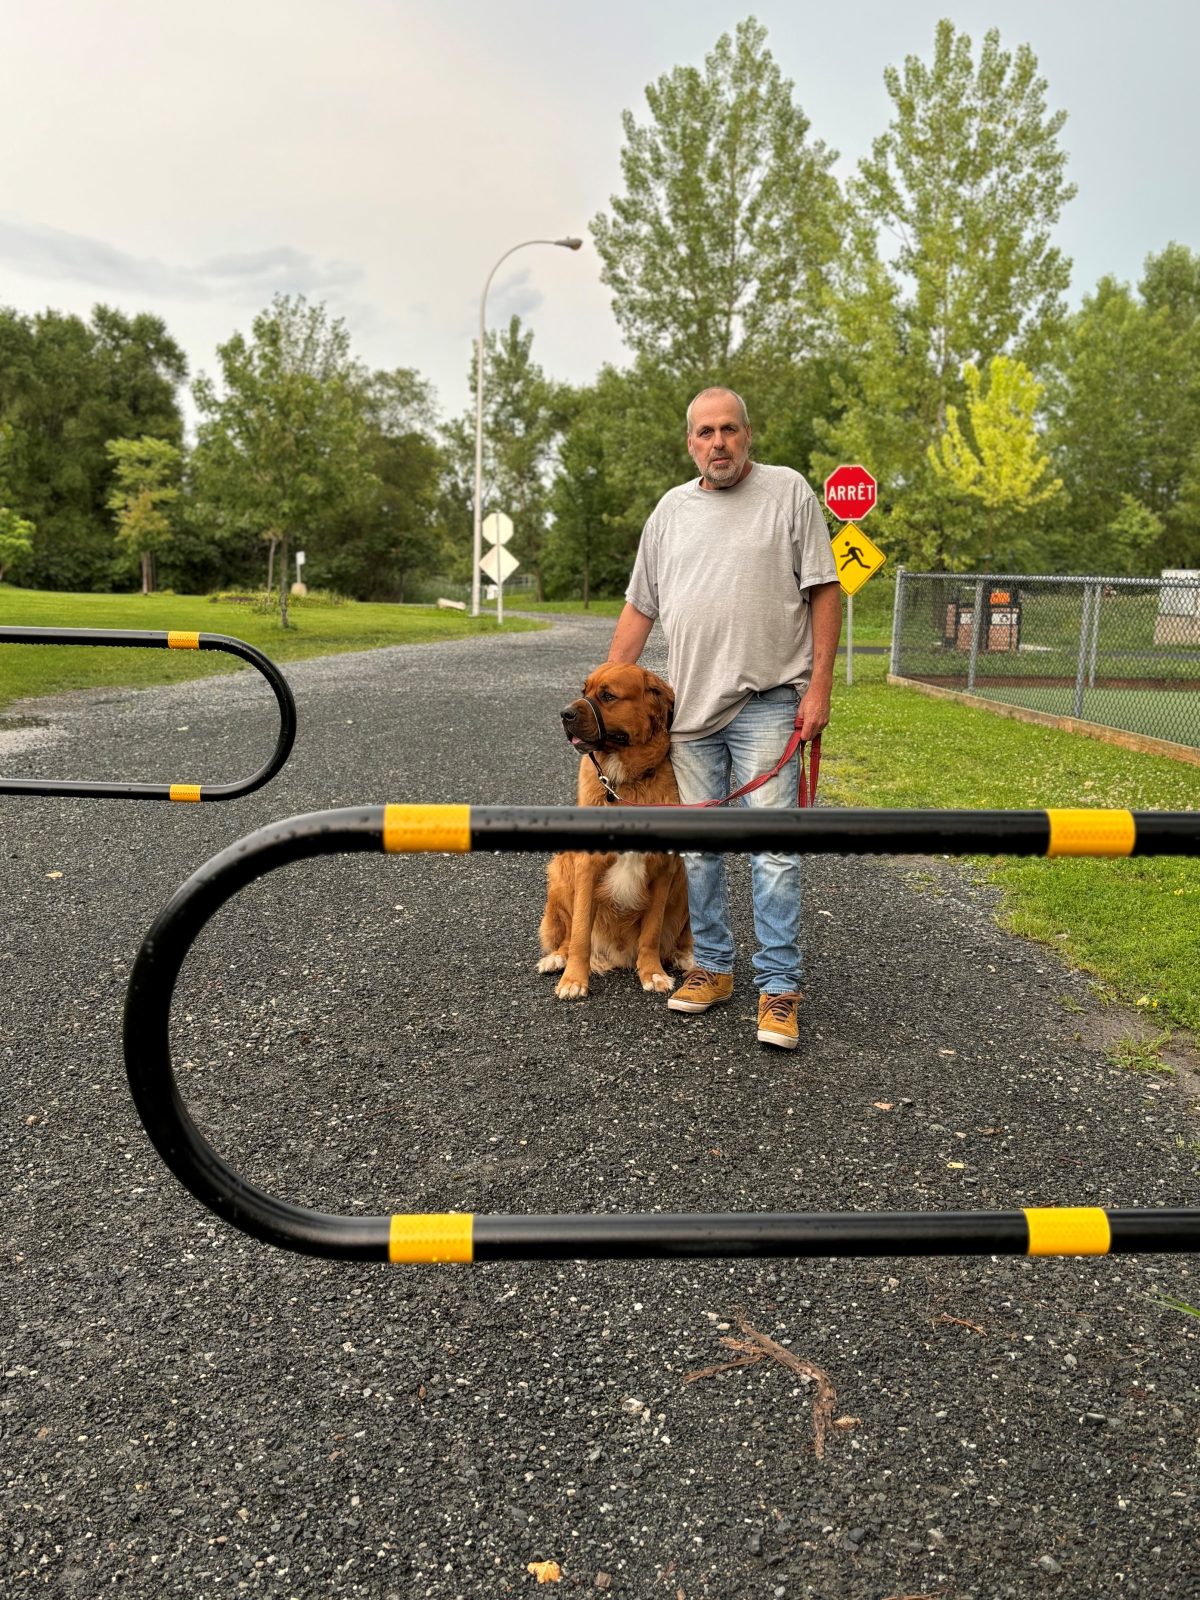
[608,389,842,1050]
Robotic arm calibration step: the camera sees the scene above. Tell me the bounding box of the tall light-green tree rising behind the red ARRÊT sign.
[814,21,1074,566]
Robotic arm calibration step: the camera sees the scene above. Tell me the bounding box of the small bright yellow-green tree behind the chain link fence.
[928,355,1062,571]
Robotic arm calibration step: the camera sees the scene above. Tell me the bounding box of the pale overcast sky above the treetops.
[0,0,1200,425]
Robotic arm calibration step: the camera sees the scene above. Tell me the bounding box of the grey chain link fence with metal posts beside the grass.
[891,568,1200,749]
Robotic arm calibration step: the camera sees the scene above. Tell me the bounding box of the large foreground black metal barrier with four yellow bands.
[125,805,1200,1262]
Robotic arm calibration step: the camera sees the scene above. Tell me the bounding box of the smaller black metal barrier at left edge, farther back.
[0,627,296,800]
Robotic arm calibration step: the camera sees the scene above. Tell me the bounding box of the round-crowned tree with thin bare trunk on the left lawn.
[194,294,371,627]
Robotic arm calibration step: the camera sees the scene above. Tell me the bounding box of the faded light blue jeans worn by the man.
[670,685,805,995]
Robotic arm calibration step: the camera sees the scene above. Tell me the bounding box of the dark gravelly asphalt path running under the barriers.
[0,619,1200,1600]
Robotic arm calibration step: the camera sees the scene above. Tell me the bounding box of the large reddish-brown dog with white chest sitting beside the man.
[538,662,693,1000]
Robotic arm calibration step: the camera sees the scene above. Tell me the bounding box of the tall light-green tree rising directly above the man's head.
[592,18,840,379]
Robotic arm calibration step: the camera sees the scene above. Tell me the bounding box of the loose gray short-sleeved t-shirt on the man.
[626,462,837,739]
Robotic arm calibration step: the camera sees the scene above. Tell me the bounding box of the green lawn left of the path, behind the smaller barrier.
[0,584,541,707]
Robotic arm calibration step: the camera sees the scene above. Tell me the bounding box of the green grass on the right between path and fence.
[821,656,1200,1029]
